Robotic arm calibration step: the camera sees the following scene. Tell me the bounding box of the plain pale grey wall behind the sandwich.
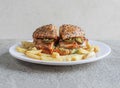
[0,0,120,40]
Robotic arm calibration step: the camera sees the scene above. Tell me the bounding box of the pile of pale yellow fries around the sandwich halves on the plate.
[16,41,99,61]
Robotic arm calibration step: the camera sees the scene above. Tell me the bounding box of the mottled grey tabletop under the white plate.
[0,40,120,88]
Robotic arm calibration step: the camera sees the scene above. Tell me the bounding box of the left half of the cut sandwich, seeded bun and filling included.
[33,24,58,54]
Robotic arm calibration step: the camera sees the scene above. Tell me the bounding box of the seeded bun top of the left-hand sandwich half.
[33,24,58,39]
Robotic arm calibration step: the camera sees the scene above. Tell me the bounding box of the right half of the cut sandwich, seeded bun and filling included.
[55,24,87,55]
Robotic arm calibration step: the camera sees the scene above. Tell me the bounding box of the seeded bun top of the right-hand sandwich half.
[59,24,85,40]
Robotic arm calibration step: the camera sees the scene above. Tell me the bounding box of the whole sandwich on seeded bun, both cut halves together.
[33,24,87,55]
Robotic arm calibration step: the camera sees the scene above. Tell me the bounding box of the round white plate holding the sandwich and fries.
[9,40,111,65]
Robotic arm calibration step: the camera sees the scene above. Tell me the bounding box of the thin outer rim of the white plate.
[9,40,111,65]
